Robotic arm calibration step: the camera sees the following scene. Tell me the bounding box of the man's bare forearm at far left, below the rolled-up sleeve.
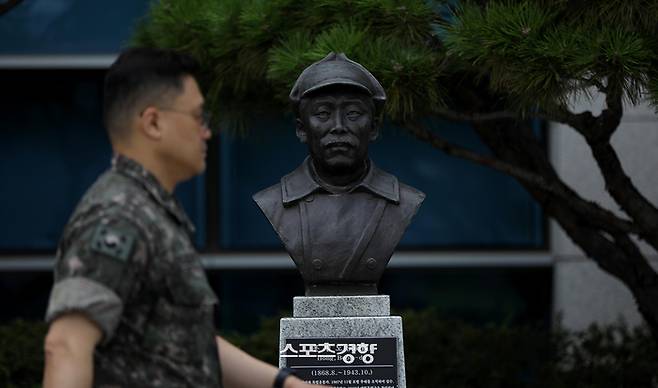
[43,313,103,388]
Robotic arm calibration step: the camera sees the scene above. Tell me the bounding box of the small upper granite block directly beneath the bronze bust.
[292,295,391,318]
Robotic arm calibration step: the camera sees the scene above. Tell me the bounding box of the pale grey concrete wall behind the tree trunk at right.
[549,94,658,330]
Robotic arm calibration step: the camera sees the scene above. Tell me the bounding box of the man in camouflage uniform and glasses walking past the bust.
[44,49,324,388]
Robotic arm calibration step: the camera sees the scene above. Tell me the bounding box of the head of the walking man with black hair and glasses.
[103,48,210,188]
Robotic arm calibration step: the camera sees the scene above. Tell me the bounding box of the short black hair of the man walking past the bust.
[103,47,199,136]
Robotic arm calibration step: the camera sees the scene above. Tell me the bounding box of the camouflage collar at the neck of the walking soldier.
[112,155,195,236]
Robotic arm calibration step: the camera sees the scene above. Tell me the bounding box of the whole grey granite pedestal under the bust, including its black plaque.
[279,295,406,388]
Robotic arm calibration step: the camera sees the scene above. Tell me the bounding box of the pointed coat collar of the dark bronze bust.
[281,157,400,206]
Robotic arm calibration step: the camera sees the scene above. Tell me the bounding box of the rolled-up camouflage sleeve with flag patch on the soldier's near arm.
[46,216,148,343]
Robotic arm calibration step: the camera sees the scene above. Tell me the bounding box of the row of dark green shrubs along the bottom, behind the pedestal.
[0,310,658,388]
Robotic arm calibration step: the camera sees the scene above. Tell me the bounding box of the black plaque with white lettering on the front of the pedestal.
[280,338,398,388]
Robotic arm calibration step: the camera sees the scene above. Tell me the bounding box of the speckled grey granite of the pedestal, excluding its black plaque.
[279,295,406,388]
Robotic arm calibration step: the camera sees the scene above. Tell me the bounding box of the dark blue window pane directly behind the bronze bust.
[219,117,545,250]
